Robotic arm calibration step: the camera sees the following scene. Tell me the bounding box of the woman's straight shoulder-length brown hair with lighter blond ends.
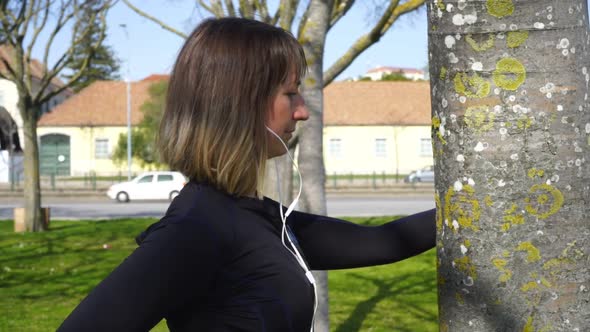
[157,18,307,196]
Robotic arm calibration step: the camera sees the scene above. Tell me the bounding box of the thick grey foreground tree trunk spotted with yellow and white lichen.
[428,0,590,332]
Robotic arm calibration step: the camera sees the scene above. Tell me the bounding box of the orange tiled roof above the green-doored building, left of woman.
[39,81,161,127]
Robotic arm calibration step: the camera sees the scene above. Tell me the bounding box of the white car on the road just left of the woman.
[107,171,186,203]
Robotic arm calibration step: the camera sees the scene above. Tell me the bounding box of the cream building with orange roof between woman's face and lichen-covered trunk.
[323,81,433,175]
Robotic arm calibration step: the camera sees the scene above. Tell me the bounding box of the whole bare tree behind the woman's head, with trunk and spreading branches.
[123,0,425,331]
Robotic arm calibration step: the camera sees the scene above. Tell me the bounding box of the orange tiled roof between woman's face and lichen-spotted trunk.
[324,81,431,126]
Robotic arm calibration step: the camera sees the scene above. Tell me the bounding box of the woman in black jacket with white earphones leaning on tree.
[59,18,435,331]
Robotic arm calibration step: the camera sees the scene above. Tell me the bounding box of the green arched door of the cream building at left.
[39,134,70,175]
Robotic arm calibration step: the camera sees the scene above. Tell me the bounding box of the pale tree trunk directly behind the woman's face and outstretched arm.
[298,0,332,332]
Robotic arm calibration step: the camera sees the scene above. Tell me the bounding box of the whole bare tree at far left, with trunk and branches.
[0,0,111,232]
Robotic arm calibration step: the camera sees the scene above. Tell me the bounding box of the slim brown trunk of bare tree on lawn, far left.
[18,94,46,232]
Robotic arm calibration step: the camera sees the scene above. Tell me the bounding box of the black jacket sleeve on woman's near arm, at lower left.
[58,220,229,331]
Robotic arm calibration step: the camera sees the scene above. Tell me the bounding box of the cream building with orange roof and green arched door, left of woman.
[37,75,168,176]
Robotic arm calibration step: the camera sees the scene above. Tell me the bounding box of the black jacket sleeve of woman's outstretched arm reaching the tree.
[289,209,436,270]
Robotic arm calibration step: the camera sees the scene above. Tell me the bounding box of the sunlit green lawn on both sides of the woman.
[0,218,438,332]
